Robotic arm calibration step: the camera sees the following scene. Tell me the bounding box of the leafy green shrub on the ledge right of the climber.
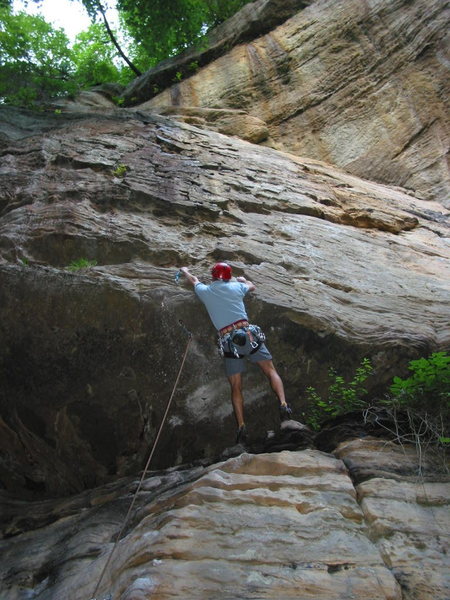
[304,352,450,474]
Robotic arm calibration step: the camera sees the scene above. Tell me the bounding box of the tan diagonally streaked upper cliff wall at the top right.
[124,0,450,206]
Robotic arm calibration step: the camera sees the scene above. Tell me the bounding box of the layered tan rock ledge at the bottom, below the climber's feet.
[0,438,450,600]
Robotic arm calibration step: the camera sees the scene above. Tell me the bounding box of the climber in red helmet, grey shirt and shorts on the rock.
[180,262,292,444]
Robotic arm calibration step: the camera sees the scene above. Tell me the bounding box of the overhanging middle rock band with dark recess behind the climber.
[0,109,450,496]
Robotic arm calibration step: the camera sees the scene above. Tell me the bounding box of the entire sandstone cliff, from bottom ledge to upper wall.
[0,0,450,600]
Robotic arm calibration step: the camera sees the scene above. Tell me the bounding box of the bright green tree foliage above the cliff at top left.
[0,0,253,106]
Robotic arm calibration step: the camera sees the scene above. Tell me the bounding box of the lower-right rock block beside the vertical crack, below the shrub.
[335,439,450,600]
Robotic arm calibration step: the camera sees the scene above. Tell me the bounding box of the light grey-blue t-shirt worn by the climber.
[194,280,248,329]
